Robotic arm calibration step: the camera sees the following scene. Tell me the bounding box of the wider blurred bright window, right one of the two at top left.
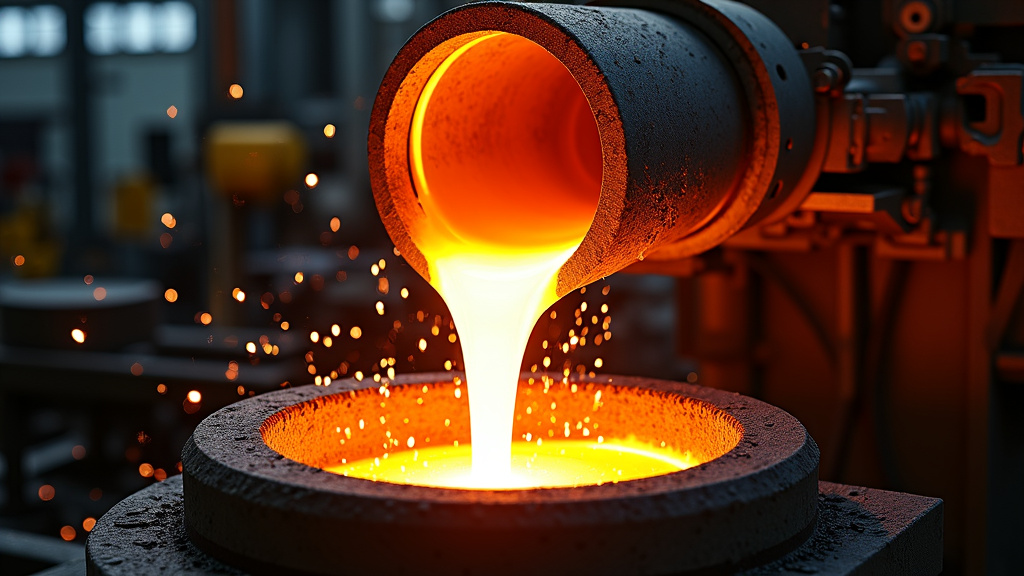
[85,2,196,55]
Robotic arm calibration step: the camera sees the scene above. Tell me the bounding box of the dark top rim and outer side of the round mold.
[182,372,818,574]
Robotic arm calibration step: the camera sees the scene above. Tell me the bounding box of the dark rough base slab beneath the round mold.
[86,476,942,576]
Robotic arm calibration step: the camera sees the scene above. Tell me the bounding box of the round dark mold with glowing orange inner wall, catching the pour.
[176,373,818,575]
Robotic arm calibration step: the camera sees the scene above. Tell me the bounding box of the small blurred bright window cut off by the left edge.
[0,4,68,58]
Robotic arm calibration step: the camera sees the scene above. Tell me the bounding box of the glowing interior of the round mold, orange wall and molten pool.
[262,368,740,489]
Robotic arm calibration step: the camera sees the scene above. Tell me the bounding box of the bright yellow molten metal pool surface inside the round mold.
[324,437,699,490]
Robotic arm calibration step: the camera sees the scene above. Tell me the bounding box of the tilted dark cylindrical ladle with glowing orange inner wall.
[369,0,814,295]
